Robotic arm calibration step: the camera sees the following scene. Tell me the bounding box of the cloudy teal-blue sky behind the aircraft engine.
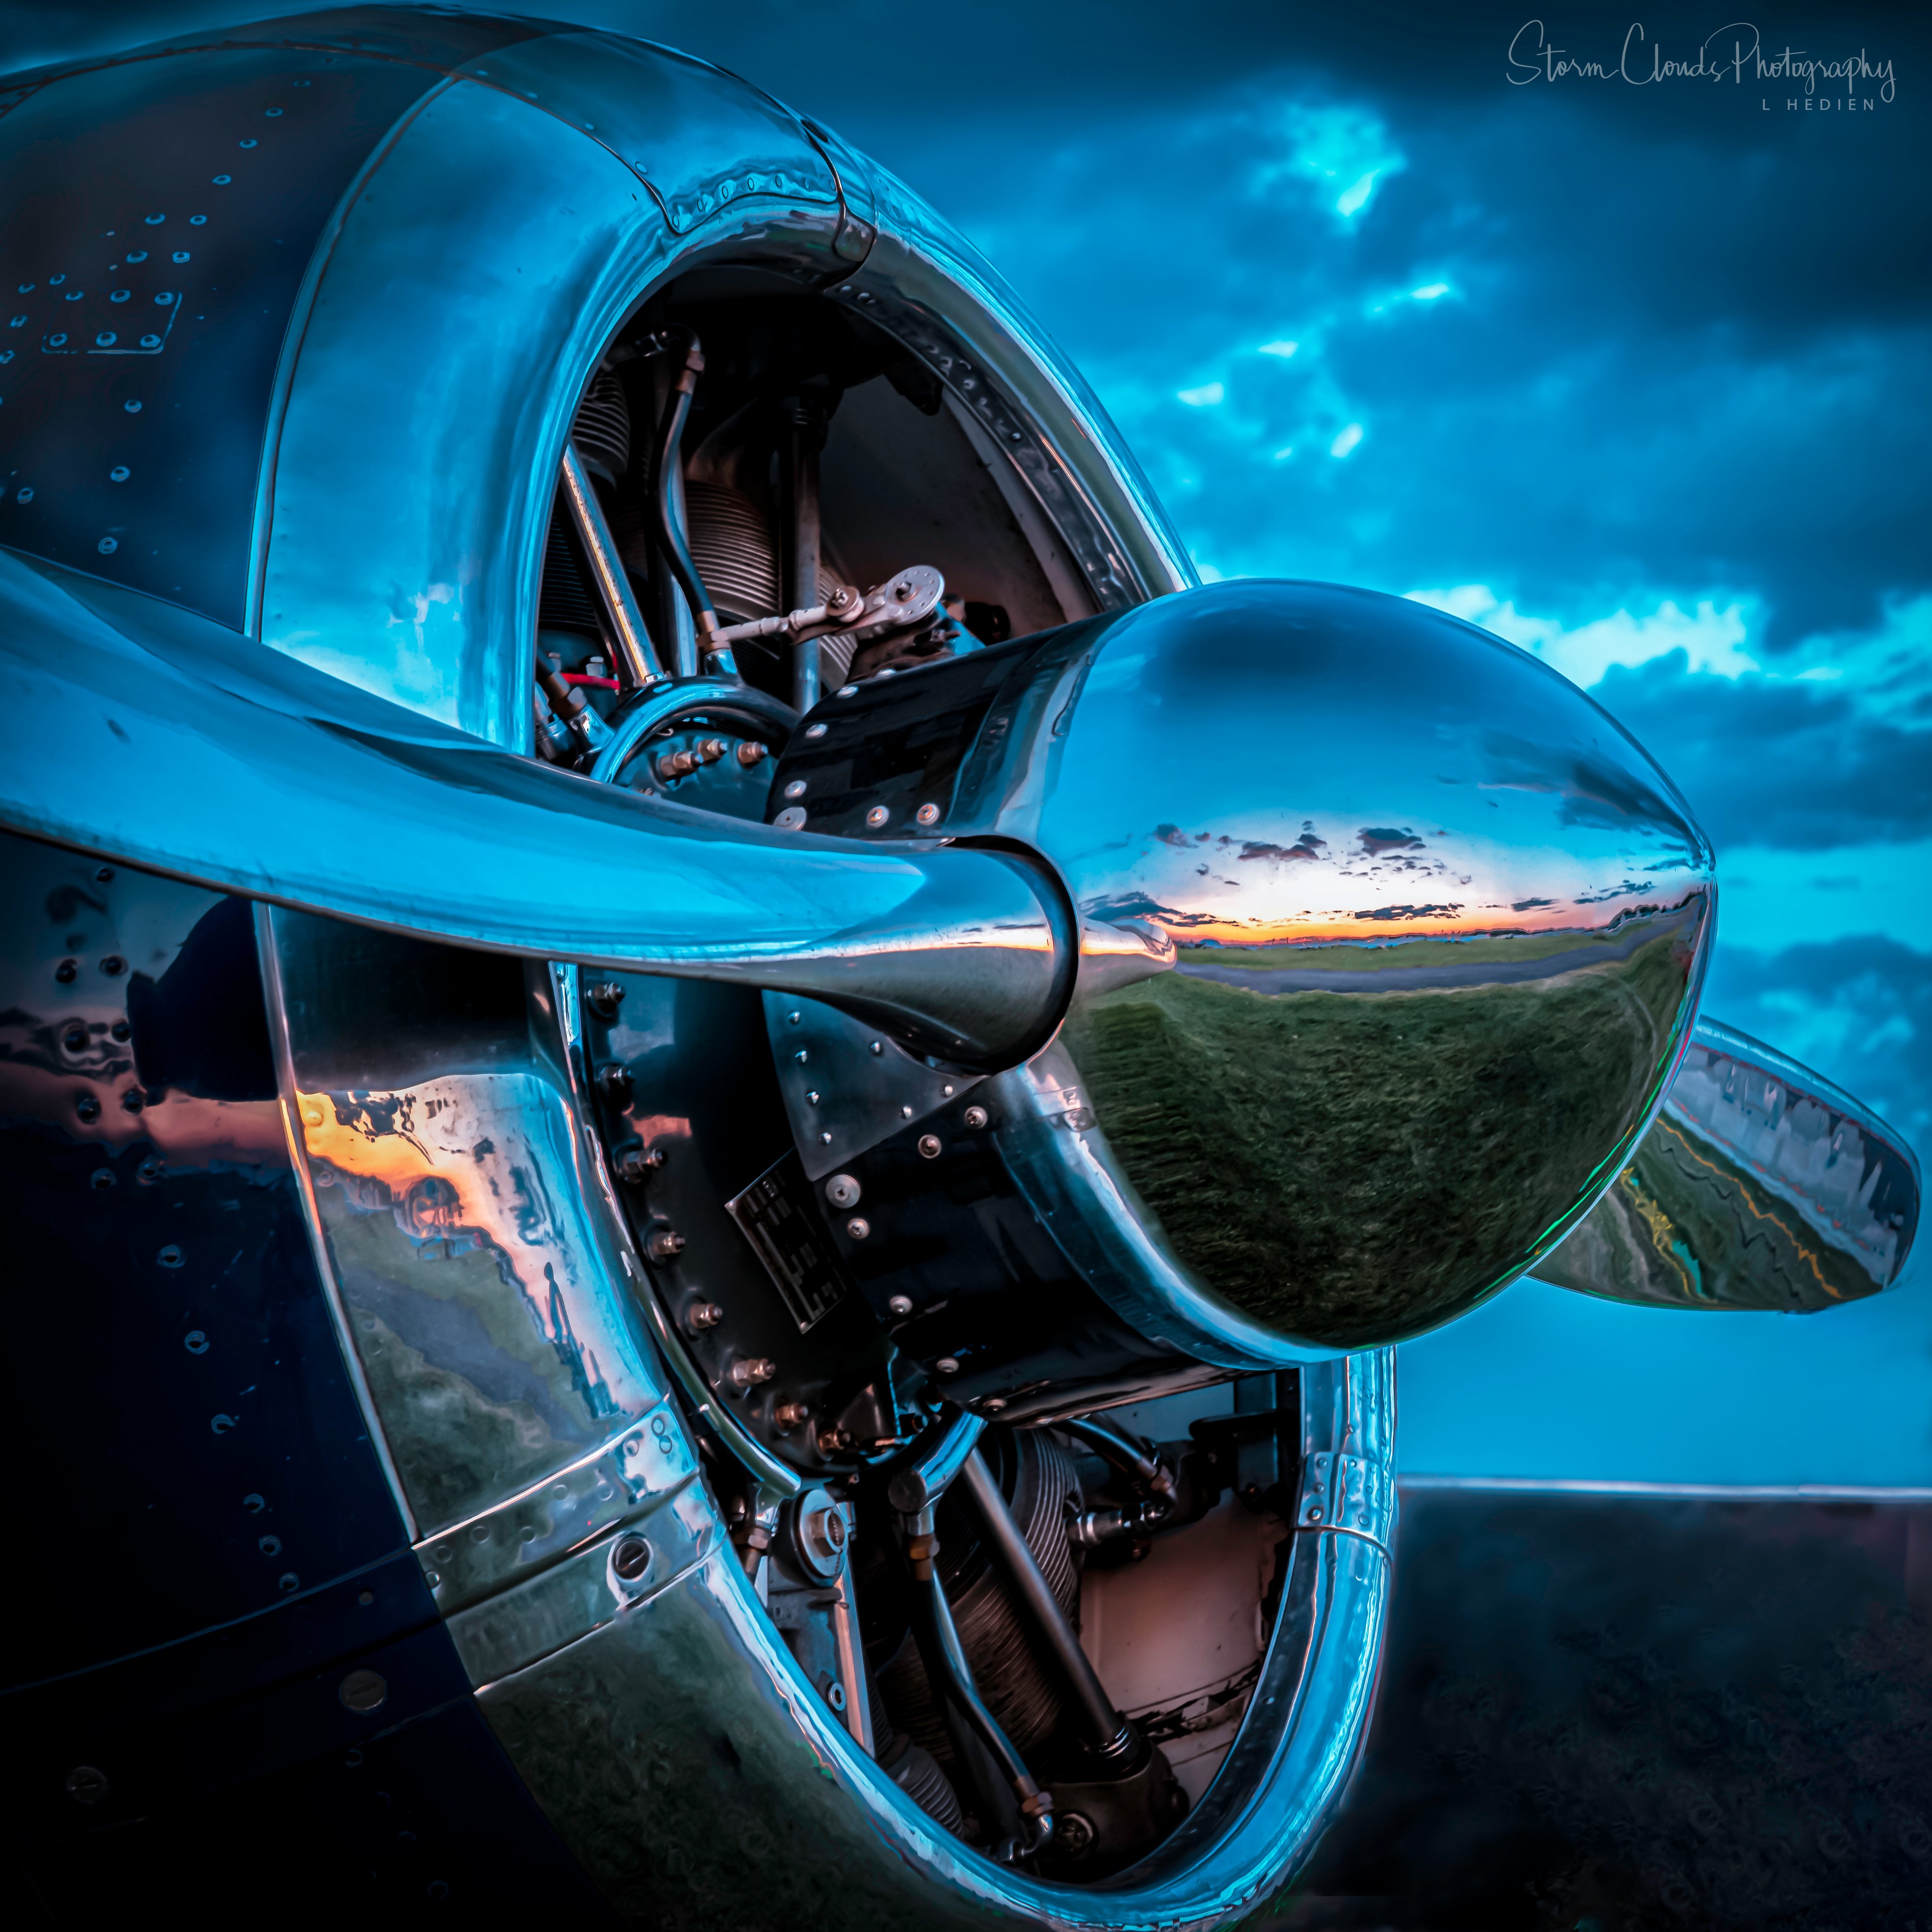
[18,0,1932,1482]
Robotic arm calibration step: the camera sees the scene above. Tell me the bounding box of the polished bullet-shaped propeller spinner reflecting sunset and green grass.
[945,582,1714,1368]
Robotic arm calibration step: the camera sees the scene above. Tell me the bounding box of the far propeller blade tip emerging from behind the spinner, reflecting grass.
[1536,1018,1918,1314]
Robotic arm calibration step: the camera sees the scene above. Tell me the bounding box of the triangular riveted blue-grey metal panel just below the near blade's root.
[765,993,980,1181]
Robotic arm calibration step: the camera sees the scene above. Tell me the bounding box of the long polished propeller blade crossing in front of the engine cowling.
[0,552,1080,1070]
